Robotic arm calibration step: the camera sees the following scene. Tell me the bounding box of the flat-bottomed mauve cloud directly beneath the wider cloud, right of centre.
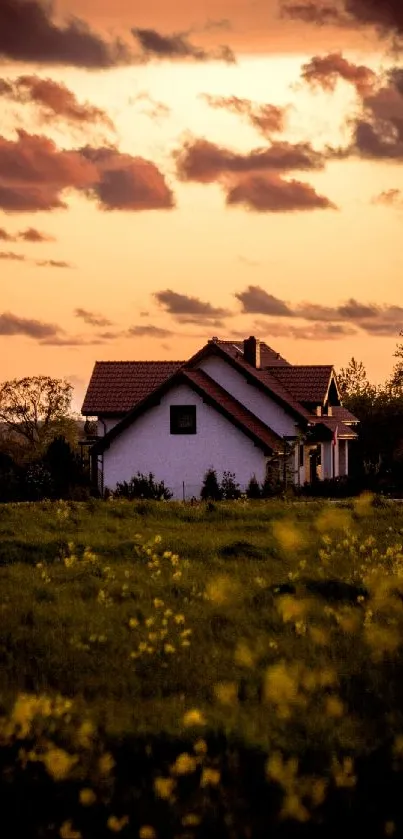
[226,175,337,213]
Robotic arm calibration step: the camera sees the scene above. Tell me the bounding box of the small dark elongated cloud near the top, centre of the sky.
[132,27,235,64]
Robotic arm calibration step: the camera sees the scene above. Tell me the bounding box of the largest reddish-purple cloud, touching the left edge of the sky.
[0,130,174,212]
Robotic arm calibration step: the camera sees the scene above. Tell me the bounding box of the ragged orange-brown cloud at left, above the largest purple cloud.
[0,75,115,131]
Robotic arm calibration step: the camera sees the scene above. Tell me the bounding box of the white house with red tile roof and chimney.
[82,336,358,499]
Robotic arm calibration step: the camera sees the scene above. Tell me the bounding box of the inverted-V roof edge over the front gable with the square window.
[93,367,283,452]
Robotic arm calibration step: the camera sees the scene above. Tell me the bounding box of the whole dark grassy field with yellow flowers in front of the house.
[0,496,403,839]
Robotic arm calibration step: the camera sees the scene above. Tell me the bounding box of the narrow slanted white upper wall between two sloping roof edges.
[199,356,296,437]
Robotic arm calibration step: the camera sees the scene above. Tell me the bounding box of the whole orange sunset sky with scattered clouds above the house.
[0,0,403,408]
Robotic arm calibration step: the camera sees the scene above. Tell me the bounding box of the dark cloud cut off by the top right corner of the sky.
[281,0,403,36]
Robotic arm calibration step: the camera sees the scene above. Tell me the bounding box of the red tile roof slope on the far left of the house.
[81,361,184,416]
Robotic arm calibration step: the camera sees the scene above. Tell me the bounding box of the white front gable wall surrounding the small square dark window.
[104,384,266,499]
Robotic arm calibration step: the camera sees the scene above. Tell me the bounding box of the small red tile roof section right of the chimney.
[269,364,333,404]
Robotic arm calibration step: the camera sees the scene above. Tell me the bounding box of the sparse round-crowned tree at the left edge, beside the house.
[0,376,73,450]
